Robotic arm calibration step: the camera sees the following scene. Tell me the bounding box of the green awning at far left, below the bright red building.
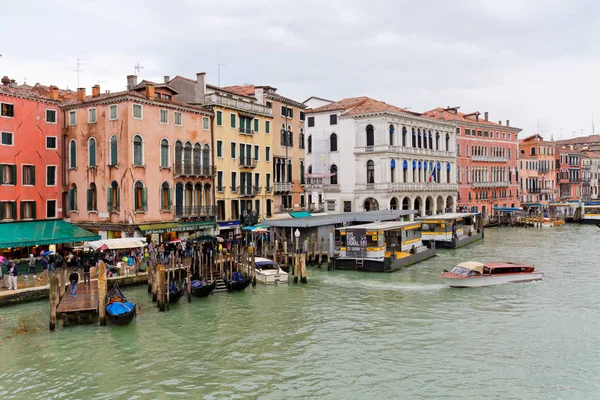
[0,220,100,249]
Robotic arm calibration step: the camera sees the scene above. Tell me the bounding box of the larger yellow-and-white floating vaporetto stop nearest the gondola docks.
[333,221,435,272]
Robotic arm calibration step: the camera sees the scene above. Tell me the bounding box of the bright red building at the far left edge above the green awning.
[0,76,63,222]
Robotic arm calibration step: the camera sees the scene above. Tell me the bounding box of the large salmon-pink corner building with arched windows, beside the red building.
[63,75,216,241]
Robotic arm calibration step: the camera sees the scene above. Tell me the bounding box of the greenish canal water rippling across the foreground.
[0,225,600,399]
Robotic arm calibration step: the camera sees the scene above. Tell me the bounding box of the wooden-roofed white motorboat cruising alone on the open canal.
[440,261,544,288]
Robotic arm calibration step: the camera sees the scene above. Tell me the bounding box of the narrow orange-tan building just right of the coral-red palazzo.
[519,135,558,208]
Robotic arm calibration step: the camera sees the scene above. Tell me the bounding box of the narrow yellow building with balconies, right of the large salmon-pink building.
[165,73,277,237]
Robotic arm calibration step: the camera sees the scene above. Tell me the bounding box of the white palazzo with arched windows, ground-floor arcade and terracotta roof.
[305,97,458,215]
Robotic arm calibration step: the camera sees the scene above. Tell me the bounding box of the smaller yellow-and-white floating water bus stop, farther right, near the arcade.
[417,213,484,249]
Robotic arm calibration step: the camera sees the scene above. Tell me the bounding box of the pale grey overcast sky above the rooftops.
[0,0,600,139]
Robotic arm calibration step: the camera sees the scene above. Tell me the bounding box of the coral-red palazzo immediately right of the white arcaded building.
[425,107,521,214]
